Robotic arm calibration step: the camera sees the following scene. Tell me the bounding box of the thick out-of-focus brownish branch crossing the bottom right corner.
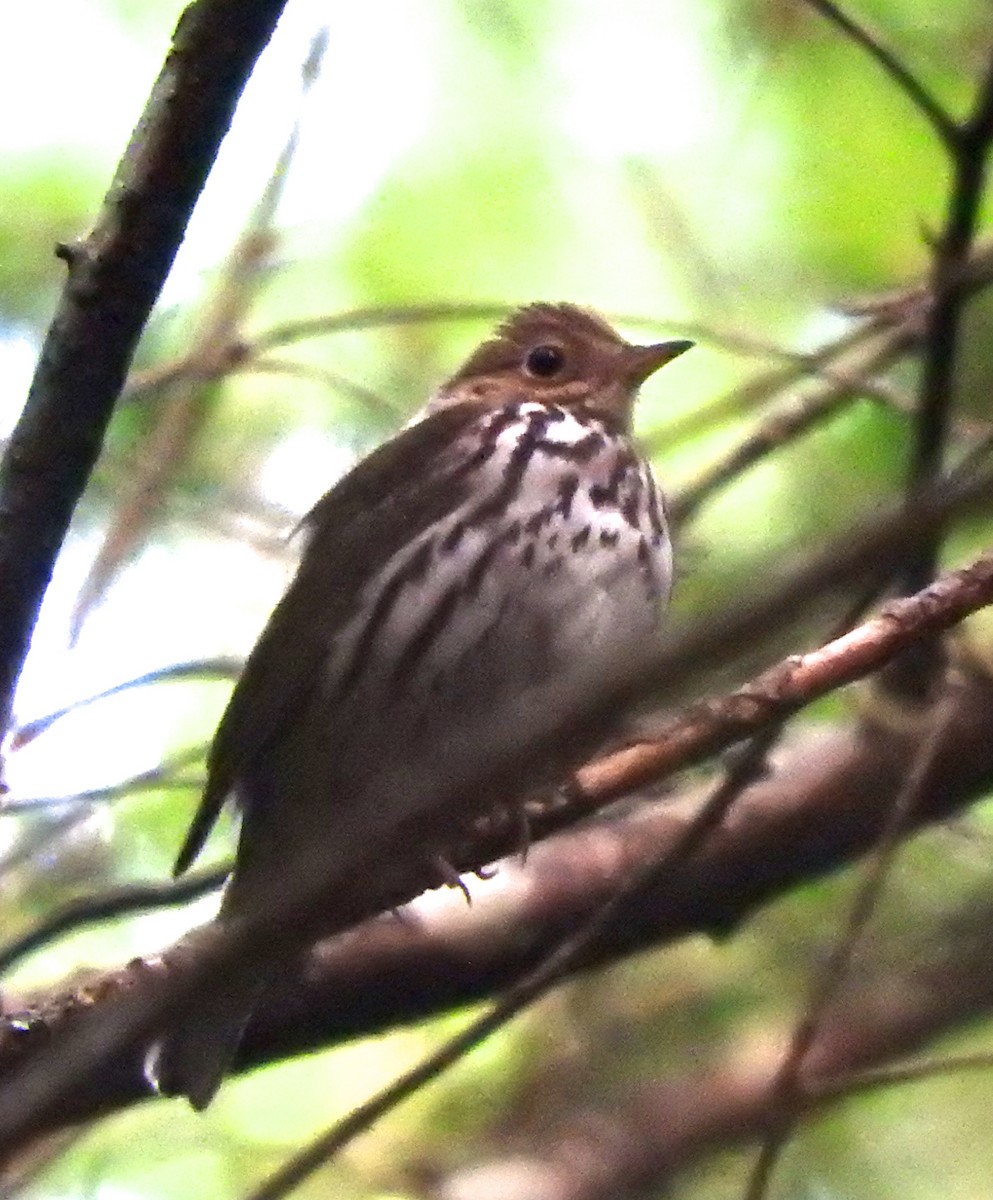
[432,898,993,1200]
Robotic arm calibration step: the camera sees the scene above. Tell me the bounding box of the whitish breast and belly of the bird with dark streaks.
[269,436,672,829]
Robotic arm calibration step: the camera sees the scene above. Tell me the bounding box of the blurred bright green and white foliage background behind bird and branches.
[0,0,993,1200]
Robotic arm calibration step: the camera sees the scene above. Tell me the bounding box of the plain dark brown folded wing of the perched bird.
[174,403,483,875]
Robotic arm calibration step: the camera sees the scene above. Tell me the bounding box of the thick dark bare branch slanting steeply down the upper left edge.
[0,0,284,732]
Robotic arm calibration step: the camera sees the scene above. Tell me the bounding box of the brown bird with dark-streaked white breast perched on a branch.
[155,304,691,1108]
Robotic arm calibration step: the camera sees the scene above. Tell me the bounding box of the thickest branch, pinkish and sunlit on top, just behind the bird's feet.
[0,662,993,1136]
